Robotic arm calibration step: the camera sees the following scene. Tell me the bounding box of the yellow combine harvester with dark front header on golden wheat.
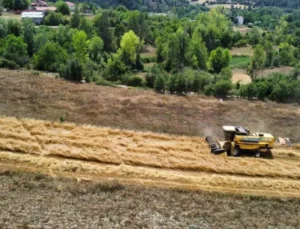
[206,126,275,157]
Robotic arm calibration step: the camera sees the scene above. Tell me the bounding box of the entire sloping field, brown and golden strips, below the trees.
[0,70,300,228]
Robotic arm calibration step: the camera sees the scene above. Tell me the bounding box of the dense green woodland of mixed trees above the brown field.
[0,2,300,102]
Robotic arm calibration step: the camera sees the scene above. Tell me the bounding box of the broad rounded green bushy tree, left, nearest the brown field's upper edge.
[33,41,67,72]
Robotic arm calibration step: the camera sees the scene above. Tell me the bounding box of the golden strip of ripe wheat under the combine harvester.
[0,117,300,197]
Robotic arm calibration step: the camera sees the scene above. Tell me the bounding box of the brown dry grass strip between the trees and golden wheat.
[0,69,300,142]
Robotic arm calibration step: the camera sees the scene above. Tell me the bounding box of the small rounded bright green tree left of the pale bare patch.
[208,47,231,73]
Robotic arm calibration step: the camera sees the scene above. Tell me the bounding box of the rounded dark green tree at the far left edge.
[2,34,28,67]
